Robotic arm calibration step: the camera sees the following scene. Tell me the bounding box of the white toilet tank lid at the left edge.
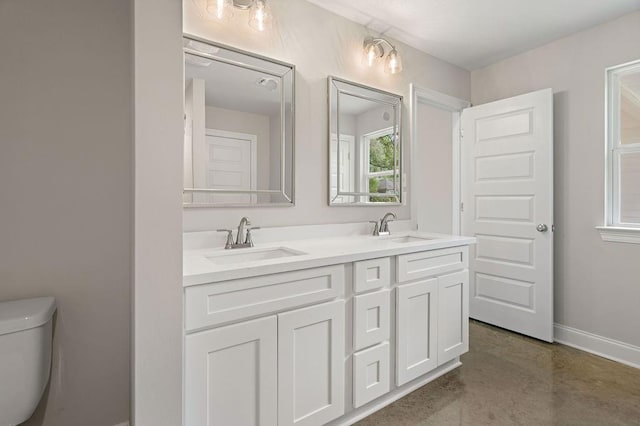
[0,297,56,335]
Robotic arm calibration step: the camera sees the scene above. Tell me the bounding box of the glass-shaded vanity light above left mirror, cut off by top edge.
[198,0,273,32]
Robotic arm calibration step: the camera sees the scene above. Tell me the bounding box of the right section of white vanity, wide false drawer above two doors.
[396,246,469,386]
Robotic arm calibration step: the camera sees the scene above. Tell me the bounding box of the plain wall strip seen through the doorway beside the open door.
[414,103,453,234]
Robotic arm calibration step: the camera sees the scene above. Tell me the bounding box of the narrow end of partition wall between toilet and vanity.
[132,0,184,426]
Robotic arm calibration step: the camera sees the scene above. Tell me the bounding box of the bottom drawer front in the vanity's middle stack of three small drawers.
[353,342,390,408]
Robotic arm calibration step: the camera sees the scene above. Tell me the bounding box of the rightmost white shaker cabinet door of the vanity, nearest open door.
[438,270,469,365]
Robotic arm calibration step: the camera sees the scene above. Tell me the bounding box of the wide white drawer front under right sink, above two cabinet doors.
[396,246,469,283]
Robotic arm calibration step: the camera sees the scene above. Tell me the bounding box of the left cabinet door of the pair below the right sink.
[396,278,438,386]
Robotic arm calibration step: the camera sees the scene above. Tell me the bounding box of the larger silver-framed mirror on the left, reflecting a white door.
[183,36,295,207]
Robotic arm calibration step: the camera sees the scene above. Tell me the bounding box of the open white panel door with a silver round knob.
[461,89,553,342]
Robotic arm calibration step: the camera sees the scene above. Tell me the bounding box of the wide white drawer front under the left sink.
[185,265,344,331]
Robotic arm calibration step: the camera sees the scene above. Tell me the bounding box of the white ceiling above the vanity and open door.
[308,0,640,70]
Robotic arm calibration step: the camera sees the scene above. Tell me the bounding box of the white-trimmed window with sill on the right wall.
[599,61,640,243]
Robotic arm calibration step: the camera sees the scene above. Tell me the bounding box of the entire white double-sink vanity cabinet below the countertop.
[184,241,469,426]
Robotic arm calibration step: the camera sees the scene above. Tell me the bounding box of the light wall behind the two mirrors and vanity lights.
[184,0,470,231]
